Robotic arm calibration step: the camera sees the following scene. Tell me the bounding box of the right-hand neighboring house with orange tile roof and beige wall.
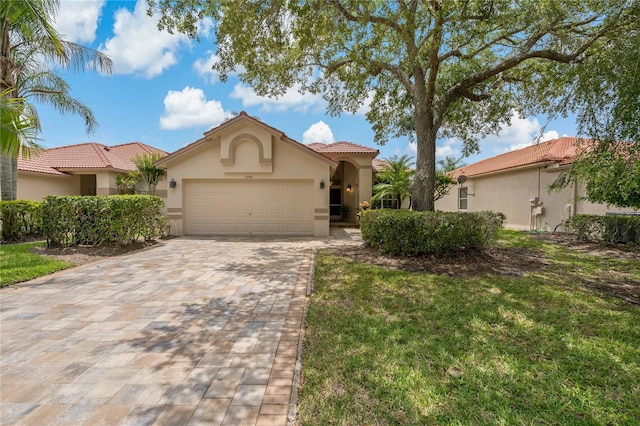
[436,137,634,231]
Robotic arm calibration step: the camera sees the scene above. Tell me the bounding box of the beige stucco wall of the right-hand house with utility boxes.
[436,167,633,231]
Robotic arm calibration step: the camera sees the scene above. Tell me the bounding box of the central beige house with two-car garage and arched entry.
[156,112,378,237]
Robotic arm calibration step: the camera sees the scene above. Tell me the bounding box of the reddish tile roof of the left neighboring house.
[18,142,166,174]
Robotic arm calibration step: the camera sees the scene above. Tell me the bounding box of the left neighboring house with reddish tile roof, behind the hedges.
[18,142,167,201]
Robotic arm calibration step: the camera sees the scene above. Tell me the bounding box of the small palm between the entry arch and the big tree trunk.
[371,155,415,208]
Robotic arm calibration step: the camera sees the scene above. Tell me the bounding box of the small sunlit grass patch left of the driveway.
[0,242,73,287]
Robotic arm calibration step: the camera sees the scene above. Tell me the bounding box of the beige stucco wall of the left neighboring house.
[18,172,80,201]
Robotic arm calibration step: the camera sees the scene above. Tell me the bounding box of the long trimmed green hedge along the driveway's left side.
[42,195,167,246]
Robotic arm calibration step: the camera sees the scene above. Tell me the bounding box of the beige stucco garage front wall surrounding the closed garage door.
[165,122,331,236]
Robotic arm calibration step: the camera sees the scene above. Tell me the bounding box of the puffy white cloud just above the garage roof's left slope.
[160,86,231,130]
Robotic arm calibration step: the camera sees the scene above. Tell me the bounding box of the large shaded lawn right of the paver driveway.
[299,232,640,425]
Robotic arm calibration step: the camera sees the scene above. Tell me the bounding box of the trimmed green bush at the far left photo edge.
[0,200,42,241]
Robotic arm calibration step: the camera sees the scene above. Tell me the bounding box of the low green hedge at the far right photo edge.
[568,214,640,247]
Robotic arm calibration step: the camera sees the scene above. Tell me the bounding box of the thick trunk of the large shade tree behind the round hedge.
[411,108,438,212]
